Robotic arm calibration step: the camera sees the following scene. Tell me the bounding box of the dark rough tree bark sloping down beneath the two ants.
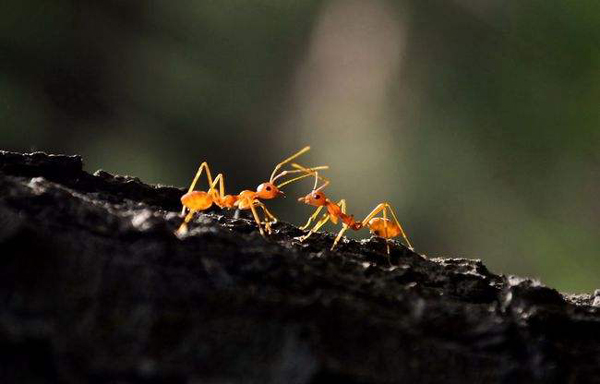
[0,152,600,383]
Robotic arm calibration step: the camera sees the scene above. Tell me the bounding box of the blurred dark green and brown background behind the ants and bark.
[0,0,600,292]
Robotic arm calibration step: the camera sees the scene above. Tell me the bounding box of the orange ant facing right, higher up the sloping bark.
[177,146,328,236]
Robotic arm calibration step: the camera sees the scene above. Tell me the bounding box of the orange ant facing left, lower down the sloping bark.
[292,164,413,255]
